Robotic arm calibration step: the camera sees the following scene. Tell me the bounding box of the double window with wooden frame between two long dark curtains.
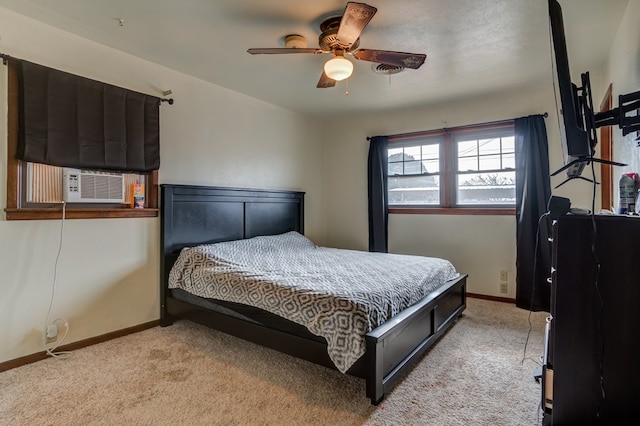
[388,121,516,214]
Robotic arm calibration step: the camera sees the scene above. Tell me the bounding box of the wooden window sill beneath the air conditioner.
[4,207,158,220]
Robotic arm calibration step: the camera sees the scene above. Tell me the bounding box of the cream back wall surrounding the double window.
[325,80,591,297]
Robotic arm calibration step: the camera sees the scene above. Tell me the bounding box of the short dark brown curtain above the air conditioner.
[17,61,160,172]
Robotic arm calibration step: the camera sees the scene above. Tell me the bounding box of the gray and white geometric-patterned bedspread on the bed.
[169,232,459,373]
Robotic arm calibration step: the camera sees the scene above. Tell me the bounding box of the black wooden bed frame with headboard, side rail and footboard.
[160,184,467,405]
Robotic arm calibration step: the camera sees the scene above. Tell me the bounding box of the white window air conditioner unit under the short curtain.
[62,167,124,203]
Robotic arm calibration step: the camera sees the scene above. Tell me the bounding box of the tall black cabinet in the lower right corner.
[542,215,640,425]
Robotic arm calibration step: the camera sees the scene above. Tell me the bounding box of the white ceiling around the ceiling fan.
[0,0,636,117]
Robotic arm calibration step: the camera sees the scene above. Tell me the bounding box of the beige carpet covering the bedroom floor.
[0,299,546,426]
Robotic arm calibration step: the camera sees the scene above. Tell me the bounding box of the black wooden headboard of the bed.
[160,184,304,310]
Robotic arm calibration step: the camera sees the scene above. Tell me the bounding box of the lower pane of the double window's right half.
[457,172,516,205]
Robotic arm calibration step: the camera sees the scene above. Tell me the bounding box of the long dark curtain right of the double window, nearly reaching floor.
[515,115,551,312]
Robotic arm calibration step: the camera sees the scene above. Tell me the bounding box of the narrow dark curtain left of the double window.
[368,136,389,253]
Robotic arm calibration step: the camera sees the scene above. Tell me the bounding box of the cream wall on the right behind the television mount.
[606,0,640,198]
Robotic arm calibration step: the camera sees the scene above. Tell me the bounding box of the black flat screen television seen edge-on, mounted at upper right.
[549,0,597,179]
